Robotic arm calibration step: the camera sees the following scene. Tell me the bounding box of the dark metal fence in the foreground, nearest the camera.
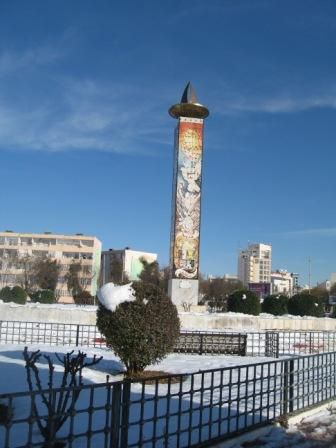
[0,352,336,448]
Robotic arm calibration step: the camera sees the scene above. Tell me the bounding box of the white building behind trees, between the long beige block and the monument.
[100,247,157,285]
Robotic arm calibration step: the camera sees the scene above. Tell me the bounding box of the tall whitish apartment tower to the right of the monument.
[238,243,272,287]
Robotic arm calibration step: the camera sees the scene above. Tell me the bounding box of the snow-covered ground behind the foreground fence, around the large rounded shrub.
[0,345,276,448]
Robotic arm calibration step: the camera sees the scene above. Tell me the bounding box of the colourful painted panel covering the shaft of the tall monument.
[171,117,203,279]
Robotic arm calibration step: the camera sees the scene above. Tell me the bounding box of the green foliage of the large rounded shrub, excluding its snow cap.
[97,282,180,375]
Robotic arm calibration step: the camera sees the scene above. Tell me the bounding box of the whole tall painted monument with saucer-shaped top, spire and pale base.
[168,83,209,306]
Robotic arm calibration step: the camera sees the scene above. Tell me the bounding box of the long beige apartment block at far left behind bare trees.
[0,231,101,303]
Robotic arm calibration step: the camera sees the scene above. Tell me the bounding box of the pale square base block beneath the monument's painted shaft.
[168,278,198,311]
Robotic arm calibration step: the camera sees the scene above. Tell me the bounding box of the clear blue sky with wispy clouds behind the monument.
[0,0,336,283]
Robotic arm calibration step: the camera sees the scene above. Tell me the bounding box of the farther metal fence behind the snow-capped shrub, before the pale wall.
[0,321,336,358]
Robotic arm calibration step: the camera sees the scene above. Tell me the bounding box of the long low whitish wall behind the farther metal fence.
[0,301,336,331]
